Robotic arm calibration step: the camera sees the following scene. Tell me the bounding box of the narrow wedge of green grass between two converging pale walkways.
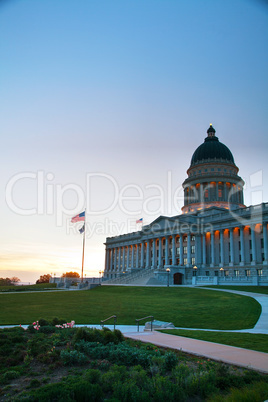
[161,329,268,353]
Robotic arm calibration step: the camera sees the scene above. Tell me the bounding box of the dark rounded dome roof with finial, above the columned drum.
[191,124,235,166]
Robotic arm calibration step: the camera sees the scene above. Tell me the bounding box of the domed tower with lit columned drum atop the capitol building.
[182,124,244,213]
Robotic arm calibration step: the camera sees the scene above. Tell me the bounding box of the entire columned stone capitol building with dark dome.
[103,125,268,286]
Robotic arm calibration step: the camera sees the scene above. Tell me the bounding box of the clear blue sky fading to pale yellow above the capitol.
[0,0,268,281]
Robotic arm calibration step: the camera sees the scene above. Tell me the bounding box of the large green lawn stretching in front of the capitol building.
[0,286,261,330]
